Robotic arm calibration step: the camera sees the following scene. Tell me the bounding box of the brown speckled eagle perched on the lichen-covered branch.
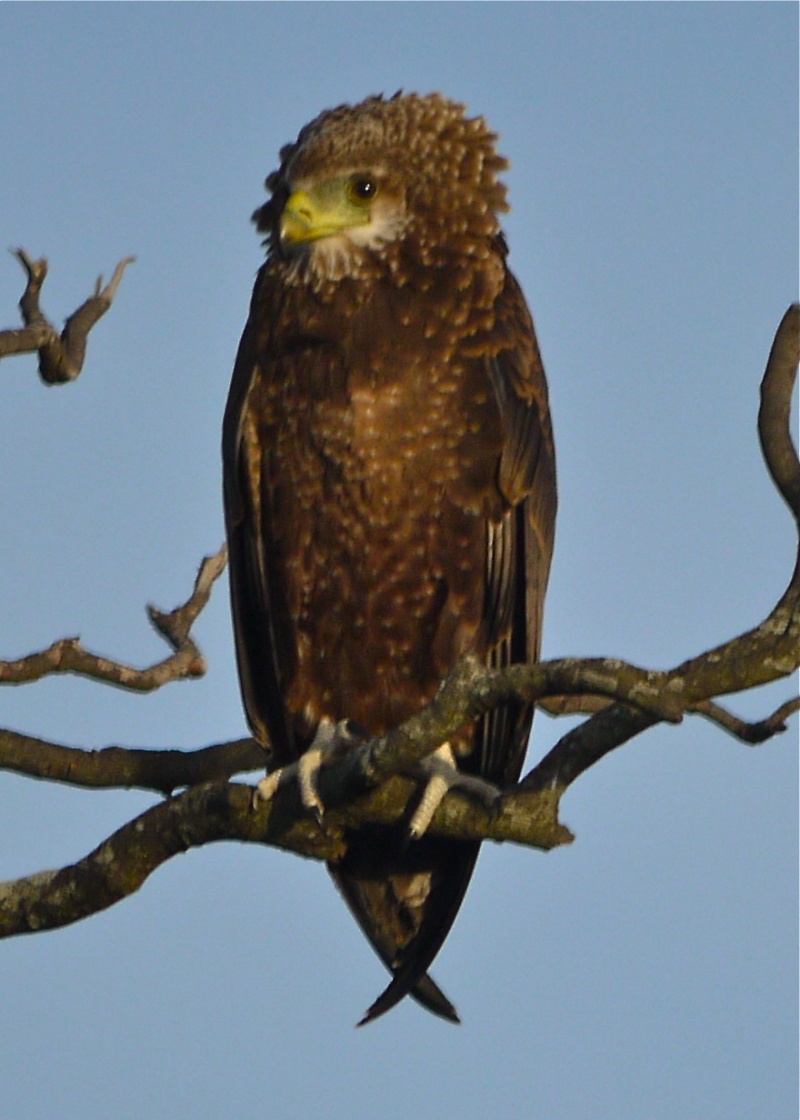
[223,93,556,1021]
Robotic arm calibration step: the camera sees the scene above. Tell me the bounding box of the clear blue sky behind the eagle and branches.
[0,3,798,1120]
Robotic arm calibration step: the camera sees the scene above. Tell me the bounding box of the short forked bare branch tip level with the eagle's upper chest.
[0,249,134,385]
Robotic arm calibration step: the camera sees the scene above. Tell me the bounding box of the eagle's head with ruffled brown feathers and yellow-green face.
[253,93,508,283]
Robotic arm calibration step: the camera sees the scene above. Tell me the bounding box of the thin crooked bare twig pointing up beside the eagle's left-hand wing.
[0,544,227,692]
